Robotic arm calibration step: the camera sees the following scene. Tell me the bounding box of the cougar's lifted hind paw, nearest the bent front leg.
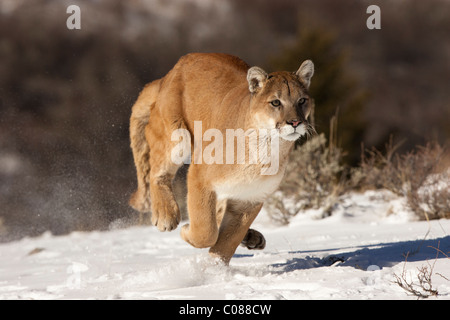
[152,200,181,231]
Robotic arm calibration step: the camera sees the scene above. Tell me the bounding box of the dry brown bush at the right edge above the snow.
[349,139,450,220]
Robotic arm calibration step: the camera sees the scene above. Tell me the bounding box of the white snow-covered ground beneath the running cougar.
[0,191,450,299]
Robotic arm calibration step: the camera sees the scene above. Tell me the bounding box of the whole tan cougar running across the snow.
[130,53,314,263]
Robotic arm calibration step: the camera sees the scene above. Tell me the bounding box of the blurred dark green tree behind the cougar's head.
[270,27,368,164]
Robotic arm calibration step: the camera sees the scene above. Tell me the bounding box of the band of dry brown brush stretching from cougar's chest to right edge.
[266,129,450,224]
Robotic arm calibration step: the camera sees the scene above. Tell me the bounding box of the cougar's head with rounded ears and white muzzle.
[247,60,314,141]
